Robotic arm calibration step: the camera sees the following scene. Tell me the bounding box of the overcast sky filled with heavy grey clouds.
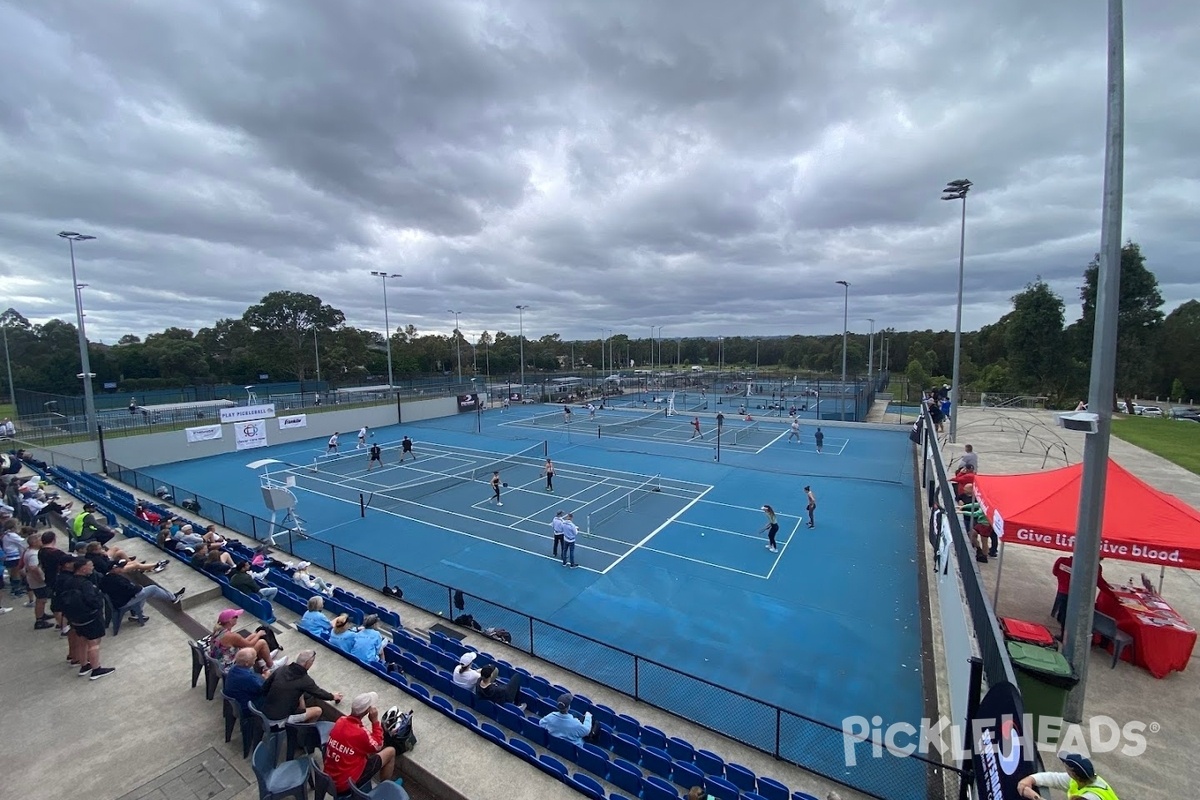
[0,0,1200,342]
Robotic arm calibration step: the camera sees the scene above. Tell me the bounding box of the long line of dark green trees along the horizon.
[0,242,1200,405]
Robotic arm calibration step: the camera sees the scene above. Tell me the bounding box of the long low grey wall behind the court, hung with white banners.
[30,397,458,473]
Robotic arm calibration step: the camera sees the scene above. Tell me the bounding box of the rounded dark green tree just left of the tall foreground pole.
[1004,277,1067,396]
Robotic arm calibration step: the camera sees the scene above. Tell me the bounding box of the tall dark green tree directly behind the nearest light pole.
[1075,241,1163,397]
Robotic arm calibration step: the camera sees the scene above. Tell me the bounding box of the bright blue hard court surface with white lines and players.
[144,405,925,786]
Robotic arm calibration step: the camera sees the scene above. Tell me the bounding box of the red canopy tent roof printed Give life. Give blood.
[976,459,1200,570]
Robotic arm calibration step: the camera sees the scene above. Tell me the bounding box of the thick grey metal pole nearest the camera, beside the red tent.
[1063,0,1124,722]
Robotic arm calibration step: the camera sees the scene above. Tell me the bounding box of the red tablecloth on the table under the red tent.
[1096,584,1196,678]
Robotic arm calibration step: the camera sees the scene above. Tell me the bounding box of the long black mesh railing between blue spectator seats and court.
[108,462,960,800]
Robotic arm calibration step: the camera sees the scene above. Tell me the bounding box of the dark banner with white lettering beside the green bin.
[968,681,1037,800]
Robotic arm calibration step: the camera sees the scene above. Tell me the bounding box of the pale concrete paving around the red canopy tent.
[942,408,1200,800]
